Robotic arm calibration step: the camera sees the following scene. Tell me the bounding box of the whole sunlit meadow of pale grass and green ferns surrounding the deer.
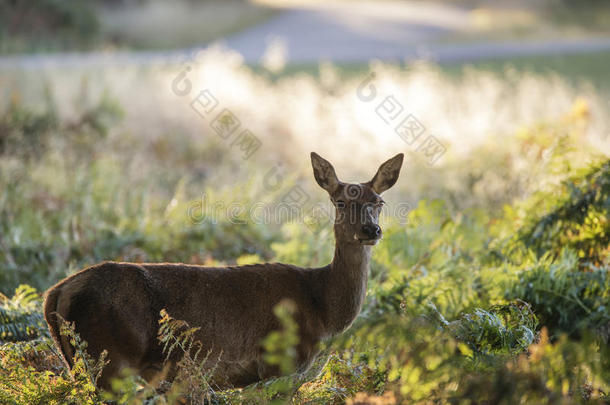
[0,49,610,404]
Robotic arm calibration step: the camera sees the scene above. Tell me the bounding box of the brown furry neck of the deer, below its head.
[324,240,371,334]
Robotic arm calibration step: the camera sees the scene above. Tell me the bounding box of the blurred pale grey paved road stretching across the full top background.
[0,1,610,70]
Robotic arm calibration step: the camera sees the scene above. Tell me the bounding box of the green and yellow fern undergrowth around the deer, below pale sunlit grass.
[0,68,610,405]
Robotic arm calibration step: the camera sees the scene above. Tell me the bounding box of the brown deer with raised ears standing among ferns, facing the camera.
[44,152,404,389]
